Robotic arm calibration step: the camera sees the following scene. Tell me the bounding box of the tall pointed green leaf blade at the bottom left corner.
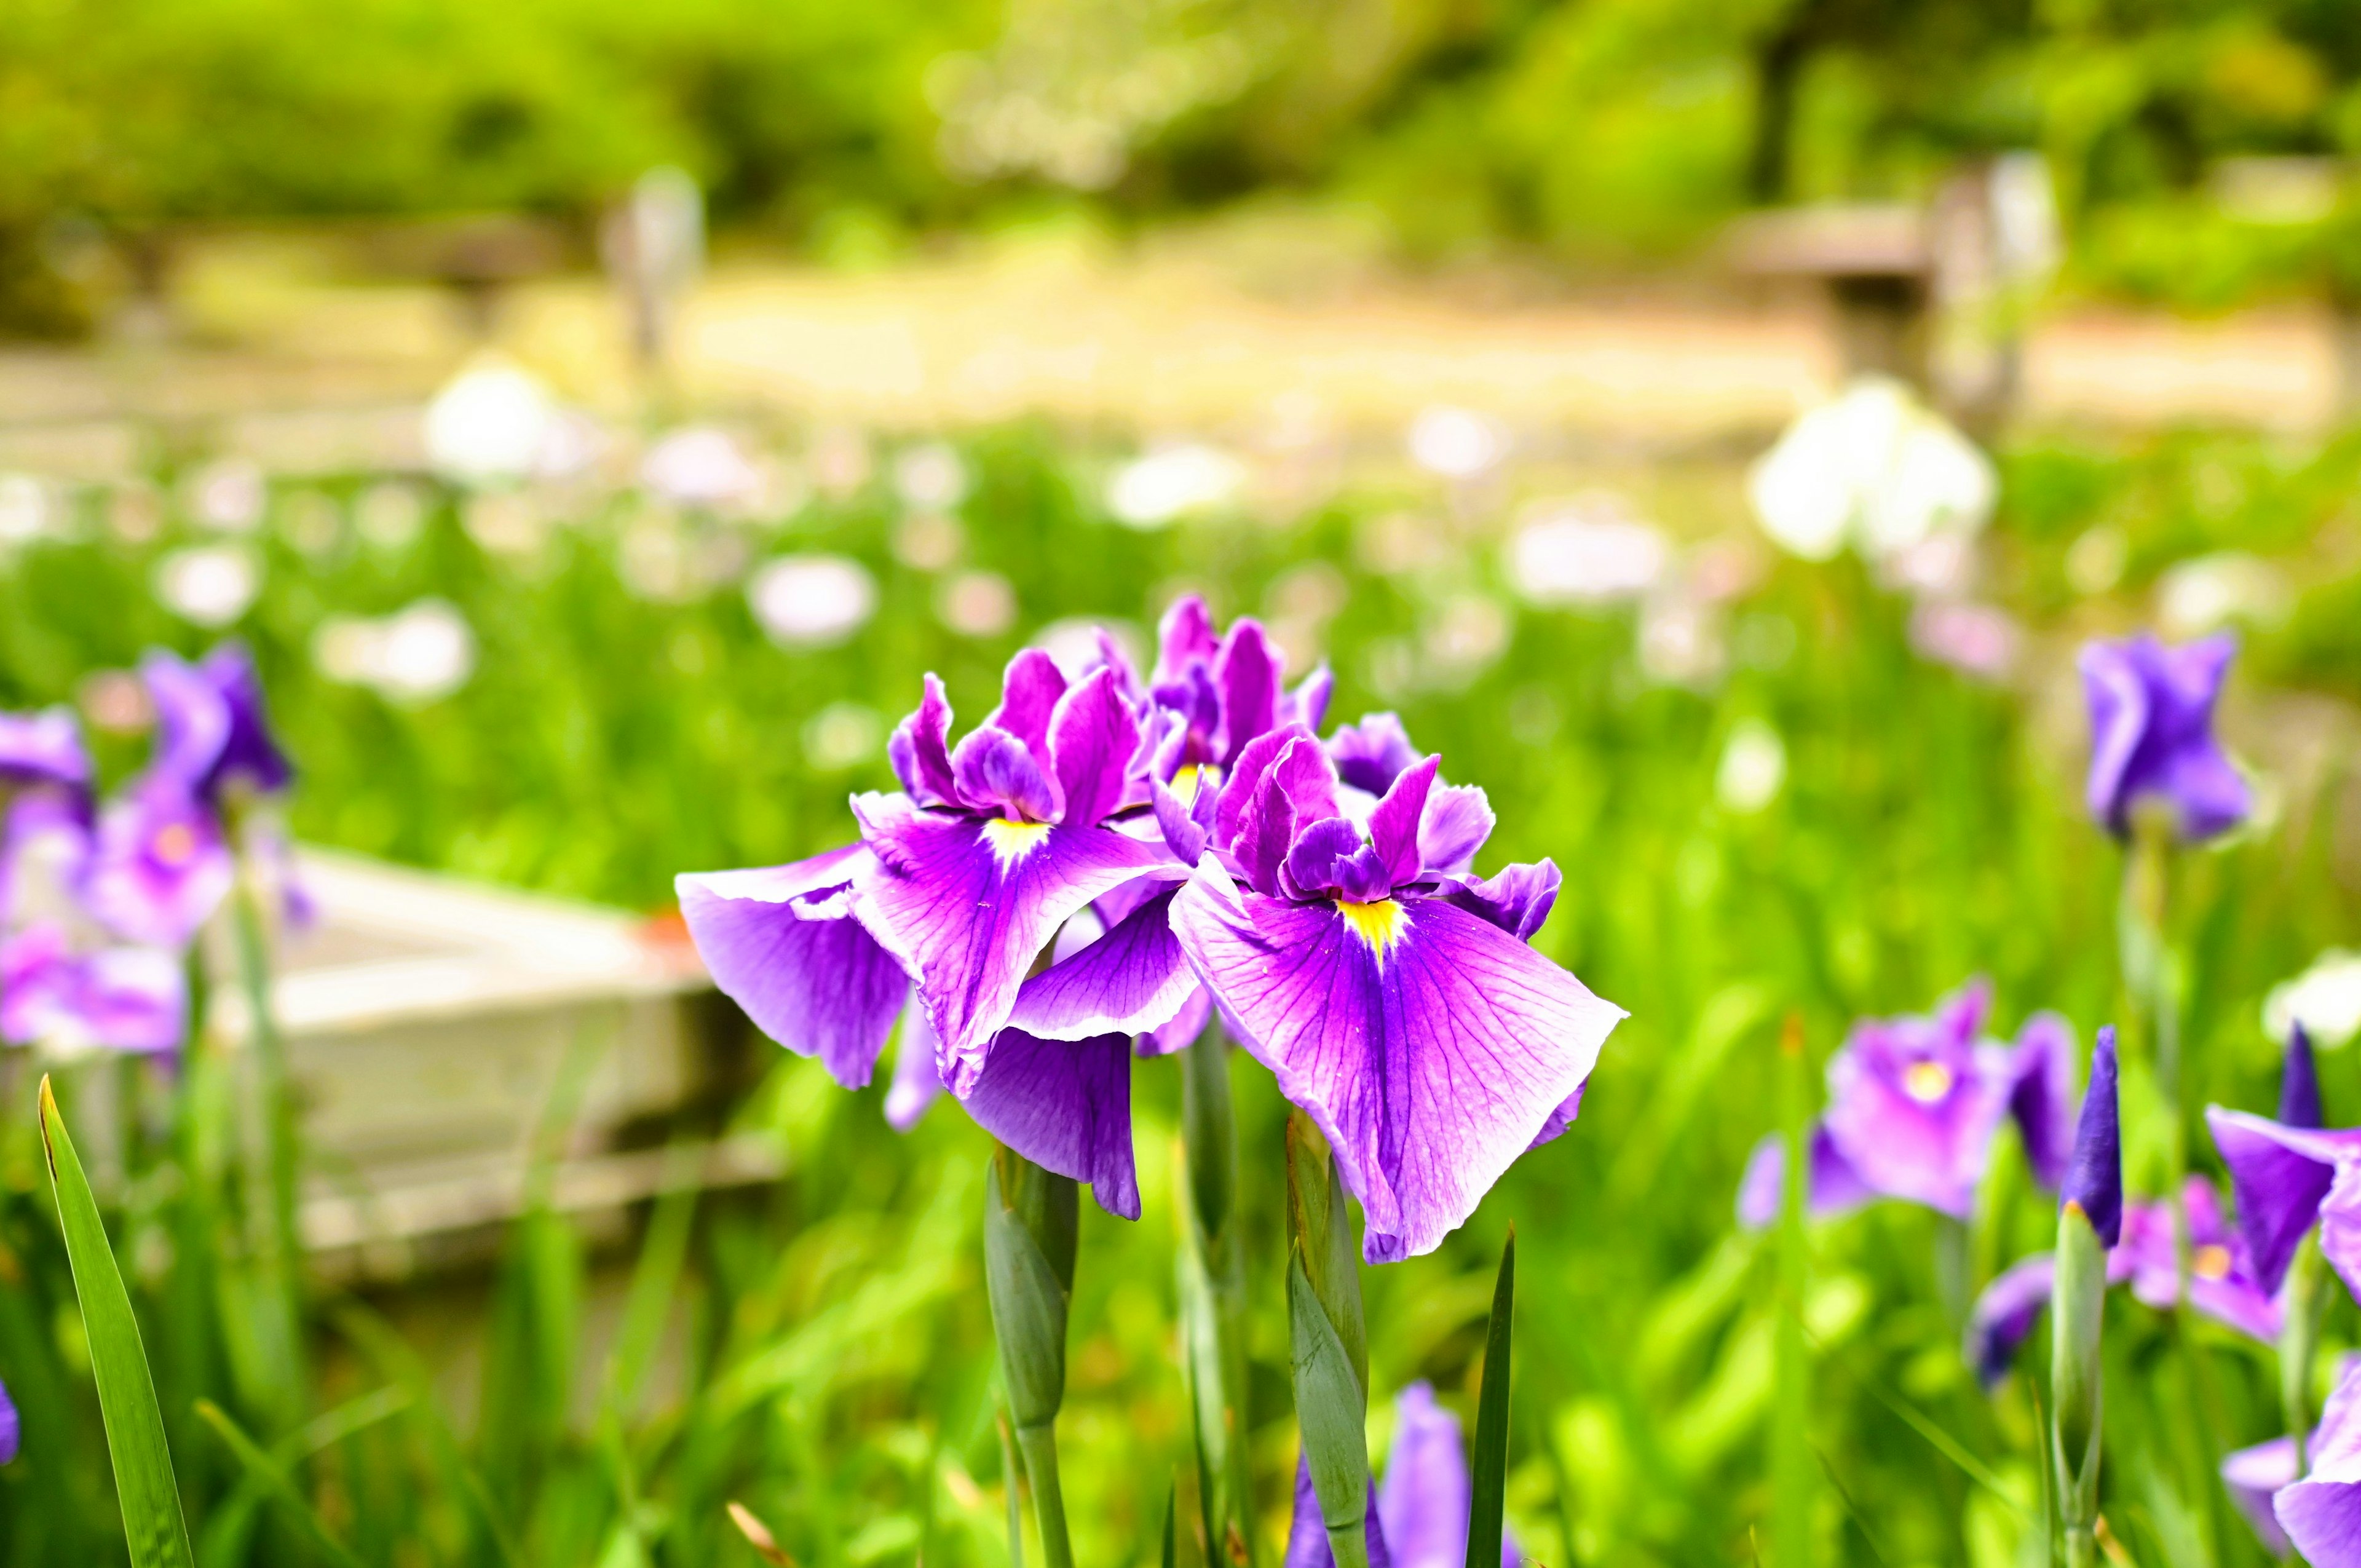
[40,1077,196,1568]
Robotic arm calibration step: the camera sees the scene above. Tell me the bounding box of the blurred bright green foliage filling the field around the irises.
[0,430,2361,1568]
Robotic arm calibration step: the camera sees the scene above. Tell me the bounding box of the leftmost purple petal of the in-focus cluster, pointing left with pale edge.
[673,843,909,1088]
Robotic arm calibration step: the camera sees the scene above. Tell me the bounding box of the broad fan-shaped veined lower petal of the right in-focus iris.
[1173,871,1624,1264]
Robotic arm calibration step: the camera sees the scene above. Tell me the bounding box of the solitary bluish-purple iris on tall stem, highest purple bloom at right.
[2080,633,2252,841]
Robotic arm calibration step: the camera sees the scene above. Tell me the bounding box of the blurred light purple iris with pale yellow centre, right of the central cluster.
[1738,980,2075,1228]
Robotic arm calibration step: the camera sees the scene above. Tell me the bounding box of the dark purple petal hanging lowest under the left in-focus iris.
[961,1029,1141,1219]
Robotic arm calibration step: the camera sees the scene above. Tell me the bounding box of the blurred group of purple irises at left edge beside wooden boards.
[0,644,290,1053]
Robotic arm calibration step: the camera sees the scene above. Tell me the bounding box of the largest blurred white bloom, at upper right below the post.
[1747,376,1999,560]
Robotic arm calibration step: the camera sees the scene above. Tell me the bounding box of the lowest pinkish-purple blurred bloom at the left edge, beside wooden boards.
[0,921,189,1053]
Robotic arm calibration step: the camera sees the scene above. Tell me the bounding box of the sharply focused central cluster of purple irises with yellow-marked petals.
[678,598,1622,1261]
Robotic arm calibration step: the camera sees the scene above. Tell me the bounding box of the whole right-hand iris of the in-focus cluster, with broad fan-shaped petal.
[1157,725,1624,1264]
